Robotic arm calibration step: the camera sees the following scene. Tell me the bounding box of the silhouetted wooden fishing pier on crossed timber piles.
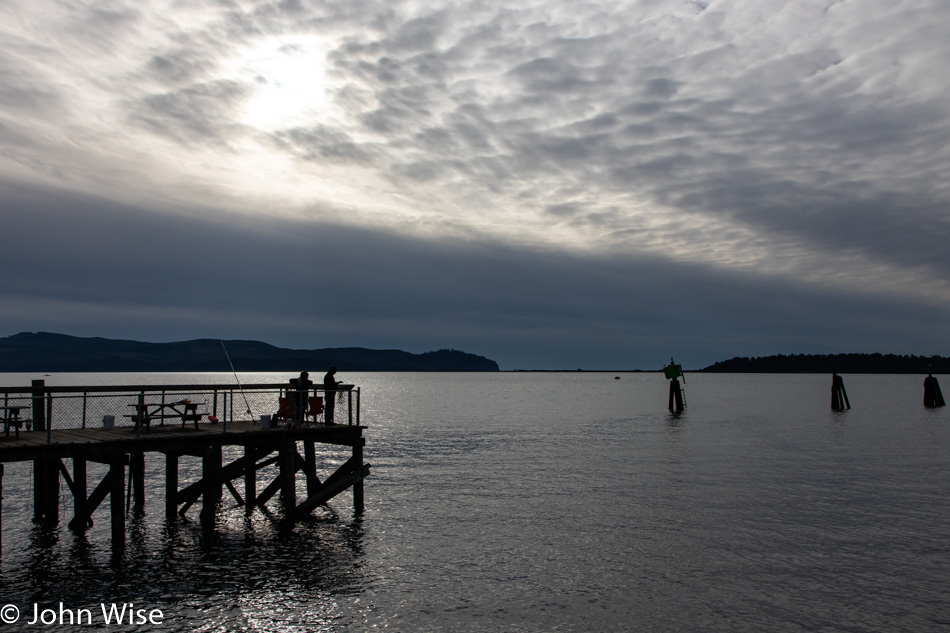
[0,381,370,547]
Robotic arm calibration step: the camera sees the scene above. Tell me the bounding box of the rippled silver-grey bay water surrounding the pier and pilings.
[0,372,950,633]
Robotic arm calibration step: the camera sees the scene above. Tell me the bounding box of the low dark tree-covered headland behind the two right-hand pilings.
[701,354,950,374]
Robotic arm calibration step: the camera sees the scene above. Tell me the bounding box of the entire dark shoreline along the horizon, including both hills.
[0,332,950,374]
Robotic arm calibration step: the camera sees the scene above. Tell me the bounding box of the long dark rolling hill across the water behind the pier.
[0,332,498,372]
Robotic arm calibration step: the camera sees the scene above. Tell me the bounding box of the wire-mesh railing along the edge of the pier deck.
[0,380,360,443]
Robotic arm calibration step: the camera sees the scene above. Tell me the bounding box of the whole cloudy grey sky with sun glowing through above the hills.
[0,0,950,370]
